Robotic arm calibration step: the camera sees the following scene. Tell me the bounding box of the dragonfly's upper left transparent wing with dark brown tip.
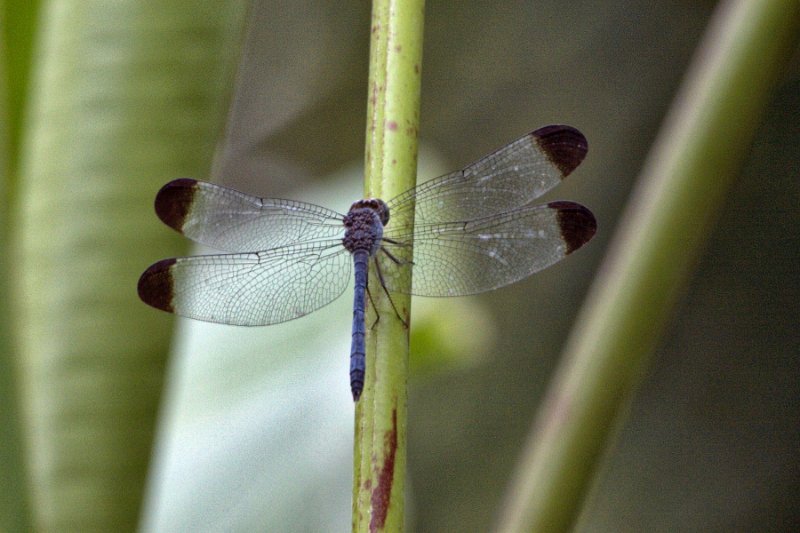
[155,178,344,252]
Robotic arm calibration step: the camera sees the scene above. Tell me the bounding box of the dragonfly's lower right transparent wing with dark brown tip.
[379,202,597,296]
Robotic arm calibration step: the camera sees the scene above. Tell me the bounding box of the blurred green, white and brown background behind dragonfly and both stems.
[0,0,800,531]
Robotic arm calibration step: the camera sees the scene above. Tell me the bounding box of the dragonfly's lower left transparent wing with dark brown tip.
[139,241,351,326]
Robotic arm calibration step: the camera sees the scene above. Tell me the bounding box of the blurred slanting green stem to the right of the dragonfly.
[498,0,800,531]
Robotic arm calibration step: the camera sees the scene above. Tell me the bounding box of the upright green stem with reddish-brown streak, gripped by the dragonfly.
[353,0,425,531]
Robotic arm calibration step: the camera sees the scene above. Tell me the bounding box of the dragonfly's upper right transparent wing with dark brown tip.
[387,125,588,232]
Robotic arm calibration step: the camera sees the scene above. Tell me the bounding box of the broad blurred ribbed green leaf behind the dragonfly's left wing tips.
[14,0,247,531]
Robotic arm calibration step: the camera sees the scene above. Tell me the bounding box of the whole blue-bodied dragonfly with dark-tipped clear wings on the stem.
[138,125,597,402]
